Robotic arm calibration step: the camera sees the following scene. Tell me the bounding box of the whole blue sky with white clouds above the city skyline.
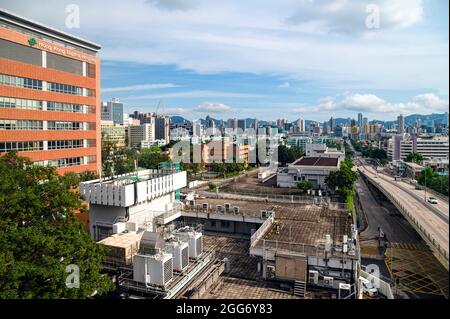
[0,0,449,120]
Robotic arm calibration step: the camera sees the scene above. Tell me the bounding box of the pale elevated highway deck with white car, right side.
[358,165,449,262]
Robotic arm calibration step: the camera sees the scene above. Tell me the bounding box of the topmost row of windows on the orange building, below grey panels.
[0,74,95,96]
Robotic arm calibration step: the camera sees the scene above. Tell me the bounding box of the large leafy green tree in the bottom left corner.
[0,153,113,298]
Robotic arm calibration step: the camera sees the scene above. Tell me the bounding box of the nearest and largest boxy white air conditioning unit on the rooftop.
[133,253,173,287]
